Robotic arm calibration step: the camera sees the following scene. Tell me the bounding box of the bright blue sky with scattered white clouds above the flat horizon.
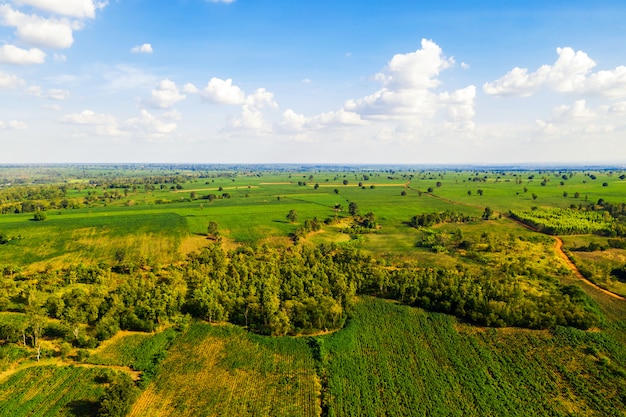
[0,0,626,164]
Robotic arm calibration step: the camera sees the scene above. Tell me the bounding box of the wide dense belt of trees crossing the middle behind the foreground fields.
[0,237,598,347]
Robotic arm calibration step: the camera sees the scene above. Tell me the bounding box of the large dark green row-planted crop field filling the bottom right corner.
[319,299,626,416]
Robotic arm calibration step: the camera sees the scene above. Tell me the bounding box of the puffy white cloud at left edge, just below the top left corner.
[0,5,75,48]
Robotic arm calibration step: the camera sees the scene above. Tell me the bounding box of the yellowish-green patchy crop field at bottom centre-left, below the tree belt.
[131,324,319,417]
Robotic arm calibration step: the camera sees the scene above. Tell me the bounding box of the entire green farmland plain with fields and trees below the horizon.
[0,165,626,417]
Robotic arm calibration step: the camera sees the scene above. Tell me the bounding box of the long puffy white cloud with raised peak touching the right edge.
[483,47,626,97]
